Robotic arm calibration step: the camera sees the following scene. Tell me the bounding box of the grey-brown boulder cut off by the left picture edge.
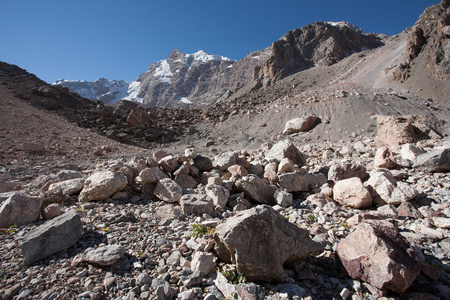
[0,192,42,228]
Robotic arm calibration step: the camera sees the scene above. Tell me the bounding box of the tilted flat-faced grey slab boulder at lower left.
[22,209,83,265]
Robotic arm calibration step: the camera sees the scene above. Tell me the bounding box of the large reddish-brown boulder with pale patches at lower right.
[336,220,420,293]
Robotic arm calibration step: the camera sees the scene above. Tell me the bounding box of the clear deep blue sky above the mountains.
[0,0,440,83]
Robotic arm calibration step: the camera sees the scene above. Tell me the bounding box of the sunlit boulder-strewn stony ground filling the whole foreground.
[0,117,450,300]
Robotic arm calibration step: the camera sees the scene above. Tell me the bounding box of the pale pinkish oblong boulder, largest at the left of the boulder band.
[78,171,128,202]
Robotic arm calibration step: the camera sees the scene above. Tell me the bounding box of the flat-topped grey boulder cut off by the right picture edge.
[414,148,450,173]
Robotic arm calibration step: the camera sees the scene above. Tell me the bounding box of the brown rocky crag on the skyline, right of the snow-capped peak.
[256,22,383,85]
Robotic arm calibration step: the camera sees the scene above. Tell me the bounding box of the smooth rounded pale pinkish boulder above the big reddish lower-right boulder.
[333,177,372,208]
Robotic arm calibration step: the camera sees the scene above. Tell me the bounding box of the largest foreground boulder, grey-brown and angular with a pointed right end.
[214,205,324,281]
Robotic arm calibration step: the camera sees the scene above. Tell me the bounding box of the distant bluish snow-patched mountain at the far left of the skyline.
[54,78,133,103]
